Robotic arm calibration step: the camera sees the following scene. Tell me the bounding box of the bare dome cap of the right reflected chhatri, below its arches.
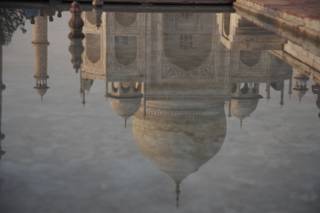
[231,96,261,119]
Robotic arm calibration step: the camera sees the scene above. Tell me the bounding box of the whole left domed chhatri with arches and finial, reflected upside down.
[107,81,143,127]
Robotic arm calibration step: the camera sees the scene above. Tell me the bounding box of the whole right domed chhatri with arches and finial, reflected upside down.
[229,83,262,126]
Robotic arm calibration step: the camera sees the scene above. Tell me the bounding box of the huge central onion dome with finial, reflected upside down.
[133,98,226,206]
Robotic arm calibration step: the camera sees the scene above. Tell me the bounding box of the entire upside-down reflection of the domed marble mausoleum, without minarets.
[75,12,298,206]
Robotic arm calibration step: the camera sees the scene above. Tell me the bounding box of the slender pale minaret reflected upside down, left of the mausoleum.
[32,15,49,101]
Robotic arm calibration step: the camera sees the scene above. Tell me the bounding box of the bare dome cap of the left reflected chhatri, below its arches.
[111,97,141,118]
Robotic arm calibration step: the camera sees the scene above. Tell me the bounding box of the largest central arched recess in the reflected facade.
[163,13,213,70]
